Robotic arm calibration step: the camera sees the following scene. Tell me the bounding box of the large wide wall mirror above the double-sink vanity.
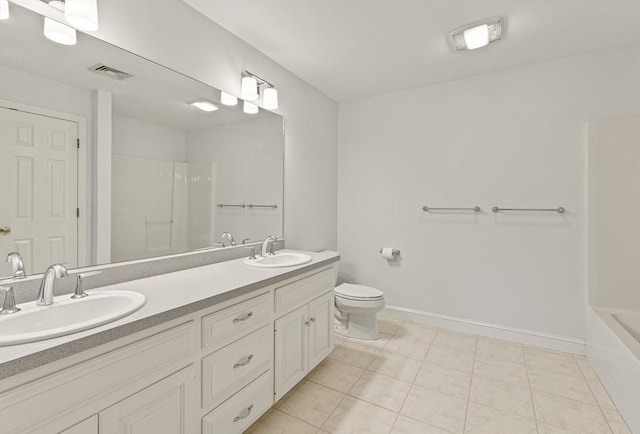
[0,4,284,277]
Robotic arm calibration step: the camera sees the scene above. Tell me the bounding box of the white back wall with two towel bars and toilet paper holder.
[338,49,640,339]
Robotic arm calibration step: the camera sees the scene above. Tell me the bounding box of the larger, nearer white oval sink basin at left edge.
[0,291,146,346]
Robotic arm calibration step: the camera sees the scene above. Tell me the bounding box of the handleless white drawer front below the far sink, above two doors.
[275,269,335,313]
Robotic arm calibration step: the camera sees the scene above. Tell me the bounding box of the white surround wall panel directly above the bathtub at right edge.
[588,117,640,312]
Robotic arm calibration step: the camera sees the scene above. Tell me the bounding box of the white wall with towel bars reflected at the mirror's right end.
[187,117,284,241]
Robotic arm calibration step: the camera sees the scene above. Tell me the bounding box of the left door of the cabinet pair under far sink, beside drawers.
[274,305,308,401]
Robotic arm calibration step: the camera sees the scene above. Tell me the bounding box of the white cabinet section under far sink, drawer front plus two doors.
[274,270,335,401]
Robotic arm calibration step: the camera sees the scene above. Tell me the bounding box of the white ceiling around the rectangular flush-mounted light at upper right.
[183,0,640,101]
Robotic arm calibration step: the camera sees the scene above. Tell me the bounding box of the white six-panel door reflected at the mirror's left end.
[0,107,78,276]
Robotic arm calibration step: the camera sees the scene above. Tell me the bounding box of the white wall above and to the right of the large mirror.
[78,0,337,250]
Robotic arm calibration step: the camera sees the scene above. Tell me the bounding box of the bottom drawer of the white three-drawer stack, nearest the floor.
[202,371,273,434]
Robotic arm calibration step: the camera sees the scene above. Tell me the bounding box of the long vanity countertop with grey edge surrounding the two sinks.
[0,250,340,380]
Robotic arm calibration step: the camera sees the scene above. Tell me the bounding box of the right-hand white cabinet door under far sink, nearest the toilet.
[308,291,334,370]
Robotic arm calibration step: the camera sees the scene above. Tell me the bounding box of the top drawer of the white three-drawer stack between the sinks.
[202,293,272,348]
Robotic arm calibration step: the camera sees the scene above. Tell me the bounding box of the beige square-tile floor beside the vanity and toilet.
[247,318,630,434]
